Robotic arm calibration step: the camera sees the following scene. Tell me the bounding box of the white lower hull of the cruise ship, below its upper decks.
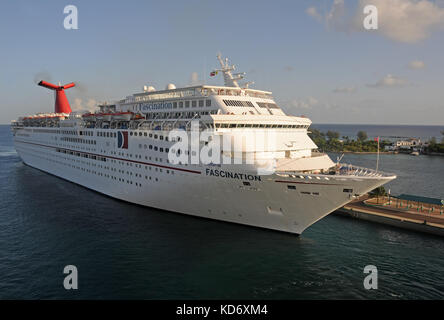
[14,129,394,234]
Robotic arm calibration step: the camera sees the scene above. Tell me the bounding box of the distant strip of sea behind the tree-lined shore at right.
[312,123,444,141]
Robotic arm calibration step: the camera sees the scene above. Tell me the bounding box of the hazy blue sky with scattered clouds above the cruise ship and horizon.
[0,0,444,125]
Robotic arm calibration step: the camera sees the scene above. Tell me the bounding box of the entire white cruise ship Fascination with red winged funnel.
[11,55,396,235]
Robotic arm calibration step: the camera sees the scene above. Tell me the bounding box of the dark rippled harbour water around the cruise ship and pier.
[0,126,444,299]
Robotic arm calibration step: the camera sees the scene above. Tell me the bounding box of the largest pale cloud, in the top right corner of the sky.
[306,0,444,43]
